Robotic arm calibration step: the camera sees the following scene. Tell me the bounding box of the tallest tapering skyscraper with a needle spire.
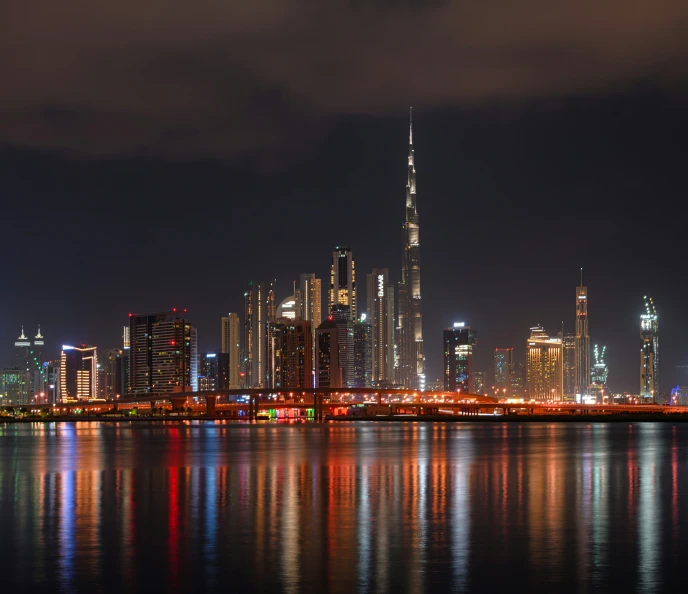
[397,108,425,390]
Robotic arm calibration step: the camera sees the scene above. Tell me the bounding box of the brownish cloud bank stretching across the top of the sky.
[0,0,688,156]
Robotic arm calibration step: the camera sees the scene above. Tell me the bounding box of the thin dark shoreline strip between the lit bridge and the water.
[0,413,688,425]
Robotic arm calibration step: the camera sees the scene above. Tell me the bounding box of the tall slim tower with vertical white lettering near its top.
[366,268,395,385]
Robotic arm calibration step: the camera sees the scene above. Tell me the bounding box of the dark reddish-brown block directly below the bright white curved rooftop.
[280,320,313,389]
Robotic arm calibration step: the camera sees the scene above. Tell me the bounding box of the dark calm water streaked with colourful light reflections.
[0,422,688,593]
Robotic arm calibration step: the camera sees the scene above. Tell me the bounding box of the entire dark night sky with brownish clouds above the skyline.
[0,0,688,393]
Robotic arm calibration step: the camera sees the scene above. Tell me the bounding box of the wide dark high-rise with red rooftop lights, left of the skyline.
[129,309,198,396]
